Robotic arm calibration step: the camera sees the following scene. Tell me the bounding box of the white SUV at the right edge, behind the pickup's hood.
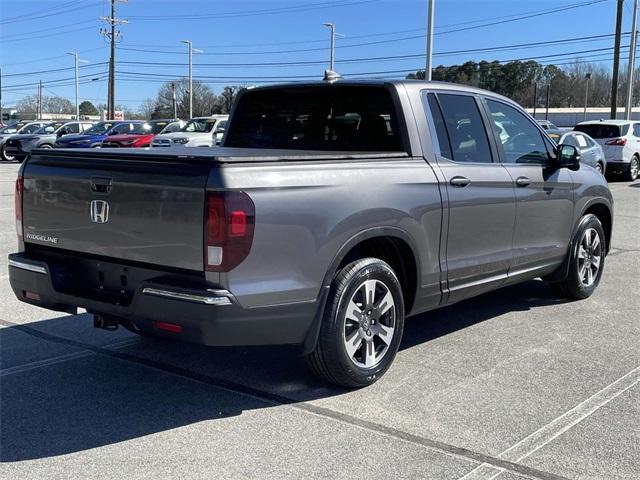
[574,120,640,181]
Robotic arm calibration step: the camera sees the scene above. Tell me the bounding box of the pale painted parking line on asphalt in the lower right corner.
[459,367,640,480]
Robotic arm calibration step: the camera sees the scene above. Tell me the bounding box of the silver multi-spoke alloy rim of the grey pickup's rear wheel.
[343,280,396,368]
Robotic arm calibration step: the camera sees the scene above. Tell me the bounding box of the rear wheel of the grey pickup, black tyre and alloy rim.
[305,258,404,388]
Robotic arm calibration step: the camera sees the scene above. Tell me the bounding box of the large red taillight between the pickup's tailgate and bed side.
[204,192,255,272]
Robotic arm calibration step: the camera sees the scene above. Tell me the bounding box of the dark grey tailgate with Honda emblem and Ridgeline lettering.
[23,151,211,271]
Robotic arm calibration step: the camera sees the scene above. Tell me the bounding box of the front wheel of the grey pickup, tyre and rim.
[549,214,607,300]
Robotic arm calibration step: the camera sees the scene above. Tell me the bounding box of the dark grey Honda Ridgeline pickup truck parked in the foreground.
[9,81,613,387]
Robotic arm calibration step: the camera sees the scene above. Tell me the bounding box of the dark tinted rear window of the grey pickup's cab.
[225,85,404,151]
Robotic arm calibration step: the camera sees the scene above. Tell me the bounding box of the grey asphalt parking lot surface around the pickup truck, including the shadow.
[0,164,640,480]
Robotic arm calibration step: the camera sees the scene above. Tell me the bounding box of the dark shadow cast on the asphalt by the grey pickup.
[0,281,559,462]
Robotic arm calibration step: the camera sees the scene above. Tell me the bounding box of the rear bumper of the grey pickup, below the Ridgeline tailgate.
[9,252,315,346]
